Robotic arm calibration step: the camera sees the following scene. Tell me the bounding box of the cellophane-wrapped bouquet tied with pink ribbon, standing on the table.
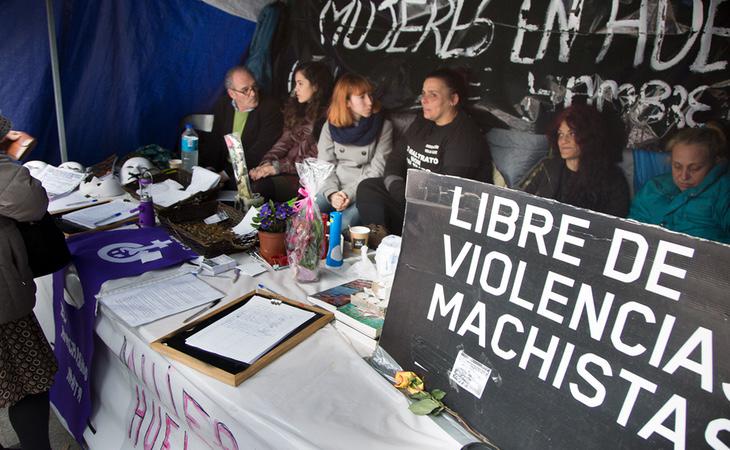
[286,158,333,283]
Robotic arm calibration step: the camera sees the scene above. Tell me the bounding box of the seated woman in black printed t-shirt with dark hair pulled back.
[357,69,492,241]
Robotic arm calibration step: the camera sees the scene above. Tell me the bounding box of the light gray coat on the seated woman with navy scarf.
[317,120,393,205]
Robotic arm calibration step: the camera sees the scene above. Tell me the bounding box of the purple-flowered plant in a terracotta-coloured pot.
[251,199,294,265]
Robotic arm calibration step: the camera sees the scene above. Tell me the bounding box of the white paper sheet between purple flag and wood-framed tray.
[97,272,224,327]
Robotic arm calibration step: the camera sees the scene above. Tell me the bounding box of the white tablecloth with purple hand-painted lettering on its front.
[36,255,471,450]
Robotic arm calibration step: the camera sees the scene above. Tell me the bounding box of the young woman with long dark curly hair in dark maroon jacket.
[249,62,332,201]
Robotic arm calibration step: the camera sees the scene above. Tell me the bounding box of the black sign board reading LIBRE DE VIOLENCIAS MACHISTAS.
[380,171,730,448]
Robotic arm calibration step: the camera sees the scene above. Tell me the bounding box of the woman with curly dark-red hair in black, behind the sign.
[521,104,630,217]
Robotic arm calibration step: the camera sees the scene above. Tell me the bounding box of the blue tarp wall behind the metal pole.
[0,0,255,165]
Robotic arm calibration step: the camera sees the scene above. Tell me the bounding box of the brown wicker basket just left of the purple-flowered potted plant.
[160,202,258,258]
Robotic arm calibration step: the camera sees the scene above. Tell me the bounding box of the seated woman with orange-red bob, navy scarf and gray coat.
[317,74,393,233]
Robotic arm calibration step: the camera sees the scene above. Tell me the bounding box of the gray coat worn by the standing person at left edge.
[0,154,48,324]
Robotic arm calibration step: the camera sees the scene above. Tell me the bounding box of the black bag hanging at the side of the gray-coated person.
[18,213,71,277]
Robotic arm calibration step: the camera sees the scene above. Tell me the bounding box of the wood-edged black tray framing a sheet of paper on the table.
[150,289,334,386]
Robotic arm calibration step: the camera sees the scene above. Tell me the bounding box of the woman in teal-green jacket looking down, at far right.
[629,128,730,243]
